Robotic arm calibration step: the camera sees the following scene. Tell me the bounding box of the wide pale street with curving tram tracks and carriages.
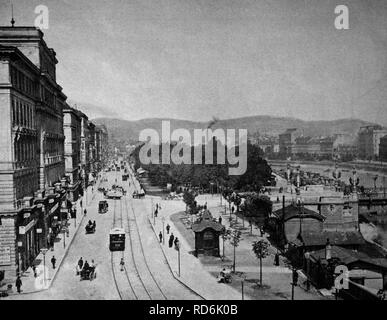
[10,171,200,300]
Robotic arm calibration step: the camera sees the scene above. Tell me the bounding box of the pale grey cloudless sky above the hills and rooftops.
[0,0,387,124]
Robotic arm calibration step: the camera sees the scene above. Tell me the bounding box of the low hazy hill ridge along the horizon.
[93,116,378,142]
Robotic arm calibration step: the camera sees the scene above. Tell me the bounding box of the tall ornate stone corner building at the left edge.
[0,27,66,277]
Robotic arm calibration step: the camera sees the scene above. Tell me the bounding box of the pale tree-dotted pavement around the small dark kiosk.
[150,195,326,300]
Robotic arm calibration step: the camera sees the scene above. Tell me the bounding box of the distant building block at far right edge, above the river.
[358,126,387,160]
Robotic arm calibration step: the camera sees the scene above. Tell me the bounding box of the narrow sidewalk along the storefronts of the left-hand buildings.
[5,182,99,297]
